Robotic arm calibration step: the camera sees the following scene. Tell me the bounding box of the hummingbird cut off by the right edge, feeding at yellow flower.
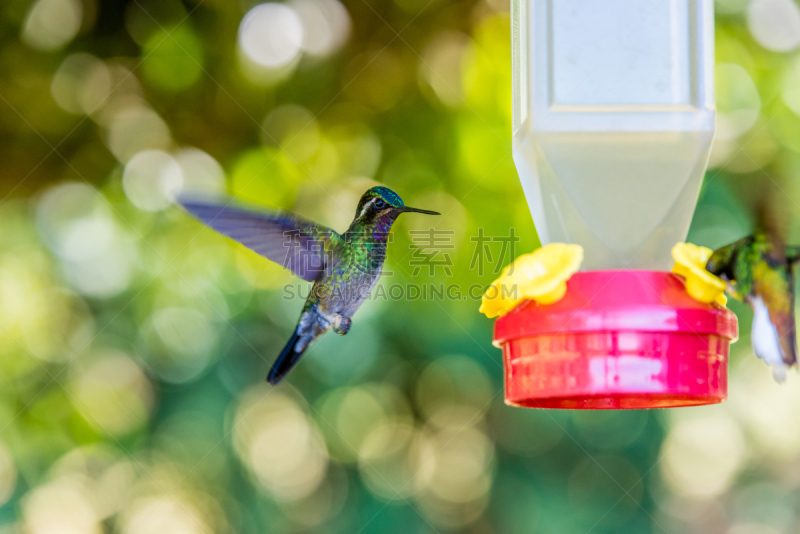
[706,230,800,382]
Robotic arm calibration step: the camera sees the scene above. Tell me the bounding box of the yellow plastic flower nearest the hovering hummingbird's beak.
[479,243,583,319]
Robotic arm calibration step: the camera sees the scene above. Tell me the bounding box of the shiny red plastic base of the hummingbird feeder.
[494,271,738,410]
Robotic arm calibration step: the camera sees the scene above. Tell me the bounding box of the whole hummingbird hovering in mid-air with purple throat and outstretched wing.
[178,186,440,385]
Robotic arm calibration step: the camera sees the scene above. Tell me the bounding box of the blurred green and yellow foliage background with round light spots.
[0,0,800,534]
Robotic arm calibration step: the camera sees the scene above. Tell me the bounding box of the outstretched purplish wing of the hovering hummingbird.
[178,198,339,282]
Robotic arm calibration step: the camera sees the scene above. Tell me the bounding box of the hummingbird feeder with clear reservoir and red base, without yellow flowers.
[494,0,738,409]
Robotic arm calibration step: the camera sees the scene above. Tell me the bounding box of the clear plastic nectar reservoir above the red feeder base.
[512,0,714,270]
